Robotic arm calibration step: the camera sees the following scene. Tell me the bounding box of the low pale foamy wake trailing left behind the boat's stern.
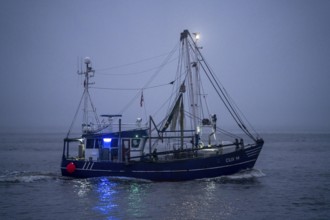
[0,171,60,184]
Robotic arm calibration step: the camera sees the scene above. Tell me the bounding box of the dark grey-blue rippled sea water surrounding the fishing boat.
[0,132,330,219]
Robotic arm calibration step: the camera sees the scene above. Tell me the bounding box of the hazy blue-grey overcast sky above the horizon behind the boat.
[0,0,330,131]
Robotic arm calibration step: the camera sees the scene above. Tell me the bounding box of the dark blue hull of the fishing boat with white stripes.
[61,144,262,181]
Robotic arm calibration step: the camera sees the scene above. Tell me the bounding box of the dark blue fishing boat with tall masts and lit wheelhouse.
[61,30,264,181]
